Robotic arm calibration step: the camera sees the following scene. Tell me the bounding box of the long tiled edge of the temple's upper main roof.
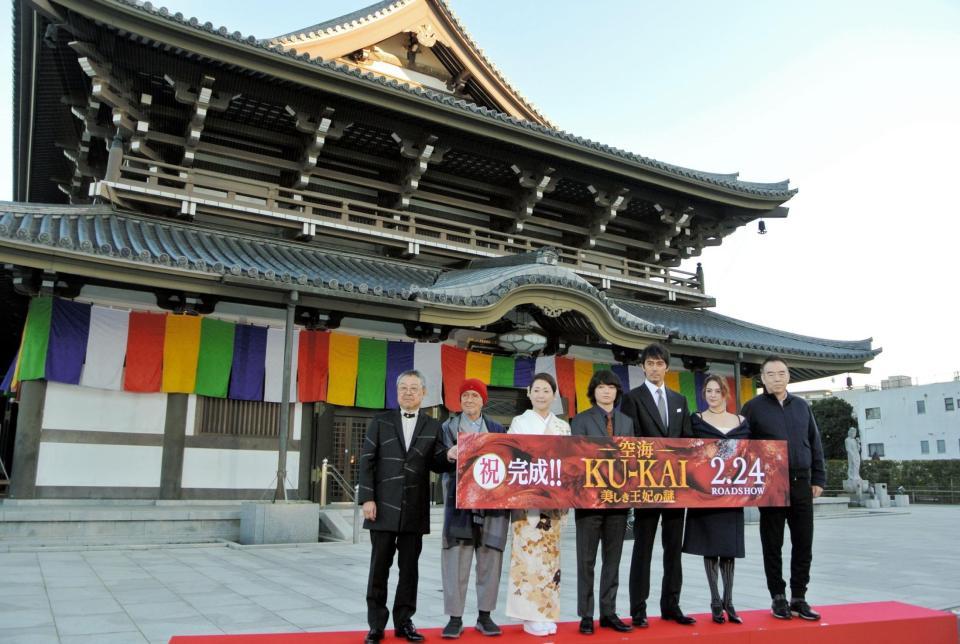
[103,0,797,203]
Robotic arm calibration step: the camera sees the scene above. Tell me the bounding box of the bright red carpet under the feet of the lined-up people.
[170,602,958,644]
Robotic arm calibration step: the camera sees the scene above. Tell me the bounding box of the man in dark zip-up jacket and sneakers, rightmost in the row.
[741,356,827,620]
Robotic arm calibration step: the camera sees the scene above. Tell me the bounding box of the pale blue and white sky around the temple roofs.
[0,0,960,389]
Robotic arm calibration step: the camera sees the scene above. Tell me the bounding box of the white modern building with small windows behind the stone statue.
[834,376,960,461]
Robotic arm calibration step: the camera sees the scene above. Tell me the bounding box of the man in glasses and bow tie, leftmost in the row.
[357,371,457,644]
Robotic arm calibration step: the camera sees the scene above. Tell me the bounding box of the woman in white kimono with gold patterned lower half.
[506,373,570,636]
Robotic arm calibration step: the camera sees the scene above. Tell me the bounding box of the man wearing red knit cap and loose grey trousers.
[440,378,510,639]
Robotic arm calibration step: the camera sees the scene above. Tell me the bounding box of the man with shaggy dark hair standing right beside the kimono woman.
[570,369,634,635]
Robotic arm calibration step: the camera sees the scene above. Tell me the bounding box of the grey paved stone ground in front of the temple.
[0,506,960,644]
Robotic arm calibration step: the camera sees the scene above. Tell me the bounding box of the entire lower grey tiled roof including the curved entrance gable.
[0,202,880,362]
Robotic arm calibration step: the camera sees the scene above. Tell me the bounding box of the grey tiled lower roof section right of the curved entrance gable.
[614,299,880,361]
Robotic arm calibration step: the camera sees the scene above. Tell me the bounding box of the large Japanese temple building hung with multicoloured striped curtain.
[0,0,879,500]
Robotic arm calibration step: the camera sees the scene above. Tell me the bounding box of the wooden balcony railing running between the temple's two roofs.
[111,155,703,295]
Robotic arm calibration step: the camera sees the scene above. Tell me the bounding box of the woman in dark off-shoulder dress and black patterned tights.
[683,375,750,624]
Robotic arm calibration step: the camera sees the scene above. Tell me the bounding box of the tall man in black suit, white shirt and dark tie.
[621,344,697,627]
